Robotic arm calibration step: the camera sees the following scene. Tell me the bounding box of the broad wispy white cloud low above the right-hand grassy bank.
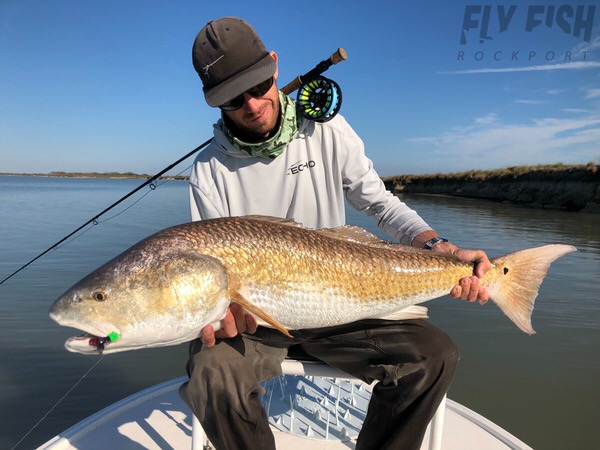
[409,112,600,171]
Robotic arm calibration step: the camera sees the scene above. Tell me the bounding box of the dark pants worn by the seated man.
[180,320,458,450]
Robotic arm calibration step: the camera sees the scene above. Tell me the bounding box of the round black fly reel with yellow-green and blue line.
[296,76,342,122]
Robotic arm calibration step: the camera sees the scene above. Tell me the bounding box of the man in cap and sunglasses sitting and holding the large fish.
[180,17,490,450]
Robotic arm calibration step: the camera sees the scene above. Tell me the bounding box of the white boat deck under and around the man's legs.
[39,361,530,450]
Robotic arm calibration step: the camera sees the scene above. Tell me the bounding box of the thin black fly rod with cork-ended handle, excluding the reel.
[0,48,347,285]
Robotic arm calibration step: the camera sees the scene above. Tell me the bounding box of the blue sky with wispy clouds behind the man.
[0,0,600,176]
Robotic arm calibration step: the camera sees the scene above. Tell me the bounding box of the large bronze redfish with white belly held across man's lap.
[49,216,576,354]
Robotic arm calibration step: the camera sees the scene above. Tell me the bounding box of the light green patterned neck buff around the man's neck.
[223,91,298,159]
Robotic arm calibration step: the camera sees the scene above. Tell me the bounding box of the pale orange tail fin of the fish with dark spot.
[484,244,577,334]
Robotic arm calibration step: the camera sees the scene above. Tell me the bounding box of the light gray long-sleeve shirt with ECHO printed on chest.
[190,115,431,245]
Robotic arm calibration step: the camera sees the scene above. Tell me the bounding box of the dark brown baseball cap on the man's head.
[192,17,277,106]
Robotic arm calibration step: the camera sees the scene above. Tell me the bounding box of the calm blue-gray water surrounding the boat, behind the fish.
[0,177,600,450]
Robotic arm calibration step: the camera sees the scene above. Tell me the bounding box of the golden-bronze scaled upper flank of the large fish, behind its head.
[188,219,464,302]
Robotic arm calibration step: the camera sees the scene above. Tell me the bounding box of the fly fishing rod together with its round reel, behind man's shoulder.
[0,48,347,285]
